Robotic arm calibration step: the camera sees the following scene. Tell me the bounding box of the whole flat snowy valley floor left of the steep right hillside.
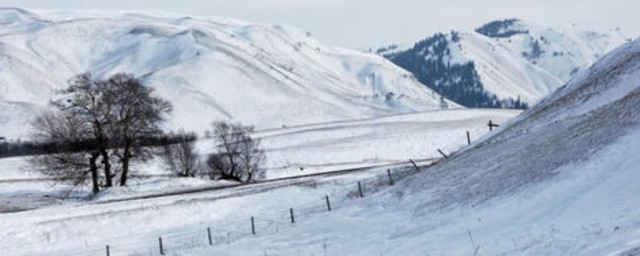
[0,110,519,255]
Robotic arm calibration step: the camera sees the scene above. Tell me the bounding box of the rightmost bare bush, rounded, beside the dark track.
[206,122,266,182]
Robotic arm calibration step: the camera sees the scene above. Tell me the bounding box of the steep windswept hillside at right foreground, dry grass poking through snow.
[192,41,640,255]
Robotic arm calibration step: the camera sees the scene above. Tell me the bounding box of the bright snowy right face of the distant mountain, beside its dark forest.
[468,18,627,103]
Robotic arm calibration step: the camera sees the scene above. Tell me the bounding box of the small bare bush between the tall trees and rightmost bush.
[160,131,198,177]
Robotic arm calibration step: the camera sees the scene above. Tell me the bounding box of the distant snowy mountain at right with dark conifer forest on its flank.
[378,19,629,108]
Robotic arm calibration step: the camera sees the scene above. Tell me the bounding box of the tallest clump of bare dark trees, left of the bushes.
[31,73,171,193]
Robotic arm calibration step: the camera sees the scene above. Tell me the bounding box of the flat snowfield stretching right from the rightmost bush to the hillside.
[245,109,520,178]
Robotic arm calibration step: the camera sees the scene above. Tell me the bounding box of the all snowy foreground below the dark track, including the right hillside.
[0,37,640,255]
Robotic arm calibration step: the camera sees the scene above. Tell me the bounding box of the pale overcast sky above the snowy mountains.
[0,0,640,49]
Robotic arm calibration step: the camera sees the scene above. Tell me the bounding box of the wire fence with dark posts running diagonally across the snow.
[65,158,432,256]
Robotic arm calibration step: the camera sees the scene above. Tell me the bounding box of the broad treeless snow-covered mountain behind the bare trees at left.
[0,8,457,140]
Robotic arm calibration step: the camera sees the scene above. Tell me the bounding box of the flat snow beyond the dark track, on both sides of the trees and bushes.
[0,109,520,212]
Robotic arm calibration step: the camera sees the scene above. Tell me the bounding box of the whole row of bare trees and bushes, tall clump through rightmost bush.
[31,73,265,197]
